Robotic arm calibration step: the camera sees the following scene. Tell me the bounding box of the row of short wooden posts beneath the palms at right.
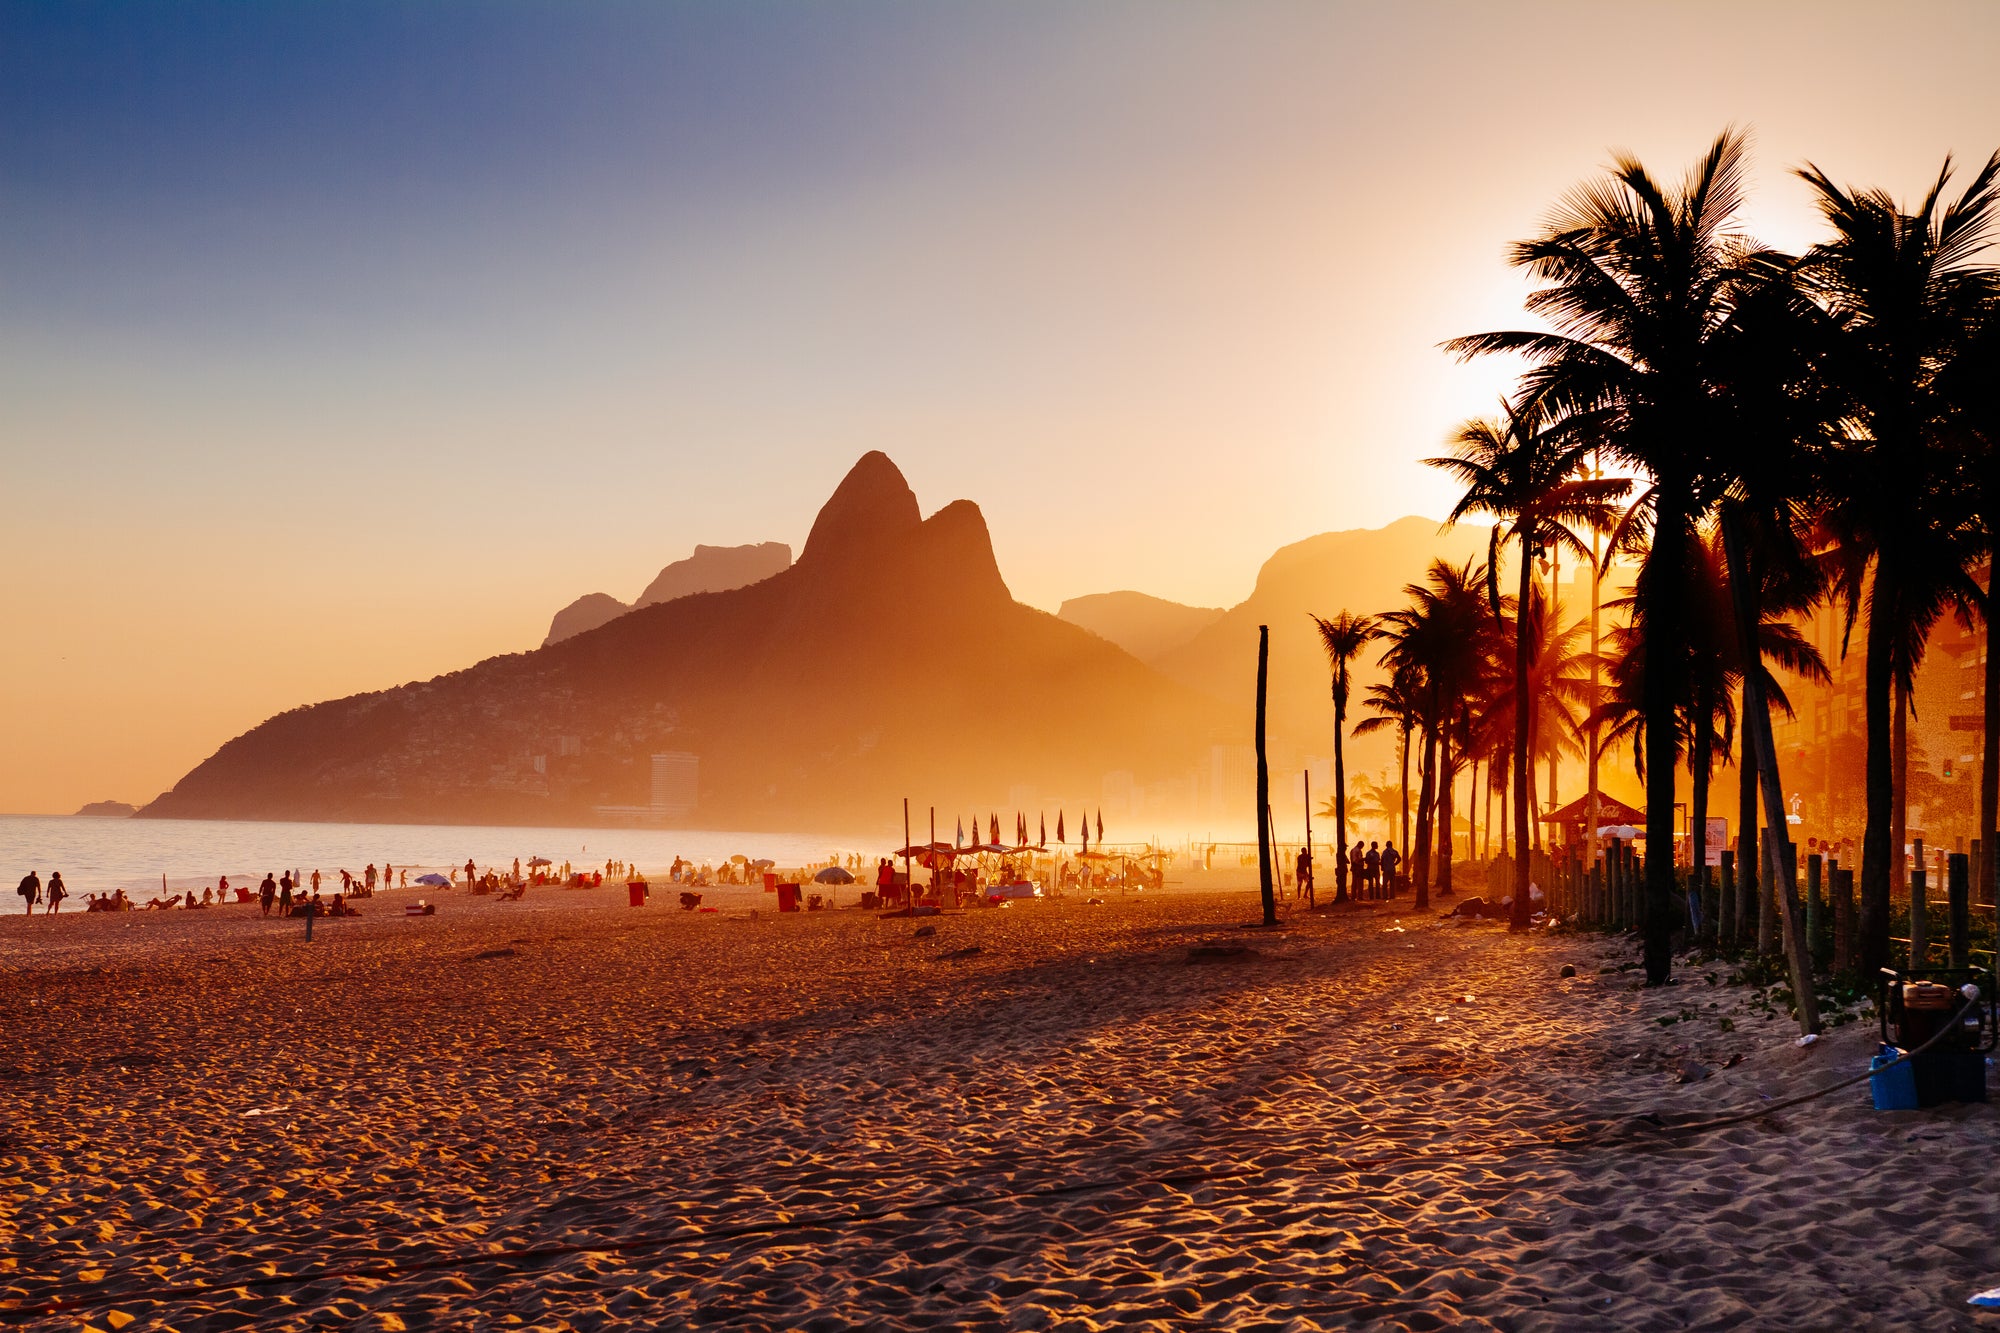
[1530,839,1978,975]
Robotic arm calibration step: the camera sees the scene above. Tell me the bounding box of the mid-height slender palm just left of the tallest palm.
[1426,402,1632,931]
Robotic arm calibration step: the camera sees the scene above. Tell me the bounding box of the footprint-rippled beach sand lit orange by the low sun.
[0,875,2000,1329]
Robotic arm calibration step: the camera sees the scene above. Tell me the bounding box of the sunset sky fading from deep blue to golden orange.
[0,2,2000,813]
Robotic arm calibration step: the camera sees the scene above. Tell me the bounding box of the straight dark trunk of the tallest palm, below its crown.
[1638,490,1688,987]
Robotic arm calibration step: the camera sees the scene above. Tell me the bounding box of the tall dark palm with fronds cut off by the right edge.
[1798,154,2000,975]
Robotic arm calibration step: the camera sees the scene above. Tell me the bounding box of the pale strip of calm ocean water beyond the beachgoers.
[0,815,876,915]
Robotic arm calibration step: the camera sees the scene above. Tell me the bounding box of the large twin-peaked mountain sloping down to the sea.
[142,452,1248,837]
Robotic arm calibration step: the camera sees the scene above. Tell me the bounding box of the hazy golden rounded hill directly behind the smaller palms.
[1154,516,1488,771]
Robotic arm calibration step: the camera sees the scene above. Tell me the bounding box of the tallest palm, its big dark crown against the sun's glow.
[1446,130,1748,985]
